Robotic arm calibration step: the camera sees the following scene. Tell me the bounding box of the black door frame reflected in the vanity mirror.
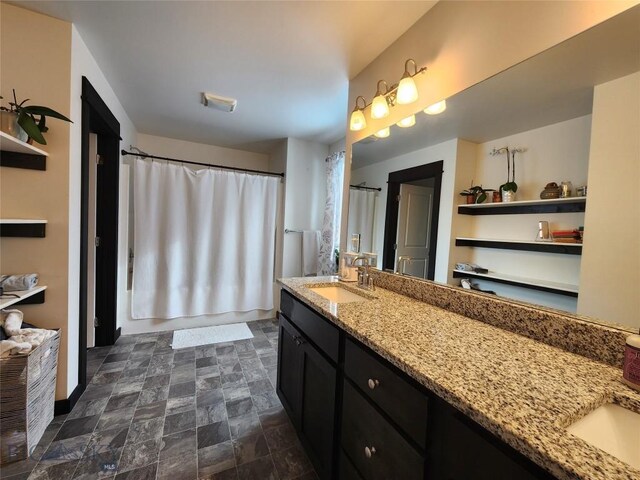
[382,160,444,280]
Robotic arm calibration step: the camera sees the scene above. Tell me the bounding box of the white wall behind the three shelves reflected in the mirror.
[460,115,591,312]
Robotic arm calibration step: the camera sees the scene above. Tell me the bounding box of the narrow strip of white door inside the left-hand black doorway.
[87,133,98,348]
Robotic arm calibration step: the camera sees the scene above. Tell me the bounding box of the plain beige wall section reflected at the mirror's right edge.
[578,72,640,330]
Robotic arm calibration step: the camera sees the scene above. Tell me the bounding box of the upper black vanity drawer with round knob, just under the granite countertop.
[344,339,429,448]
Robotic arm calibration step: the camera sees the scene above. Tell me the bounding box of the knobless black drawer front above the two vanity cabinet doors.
[280,289,340,363]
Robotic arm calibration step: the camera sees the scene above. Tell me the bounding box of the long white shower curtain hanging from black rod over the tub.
[132,160,279,319]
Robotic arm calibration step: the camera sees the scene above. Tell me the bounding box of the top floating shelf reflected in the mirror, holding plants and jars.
[458,197,587,215]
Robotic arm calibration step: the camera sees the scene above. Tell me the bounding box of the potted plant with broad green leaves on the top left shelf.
[0,89,73,145]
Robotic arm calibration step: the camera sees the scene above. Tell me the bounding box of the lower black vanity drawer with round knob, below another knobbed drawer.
[342,380,425,480]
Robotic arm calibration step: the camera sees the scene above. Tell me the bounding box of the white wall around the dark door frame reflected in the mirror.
[351,139,458,282]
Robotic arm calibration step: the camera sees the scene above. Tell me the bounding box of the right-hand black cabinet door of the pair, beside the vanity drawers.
[299,332,338,479]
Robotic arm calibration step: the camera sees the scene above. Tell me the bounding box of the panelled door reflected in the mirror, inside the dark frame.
[396,183,433,278]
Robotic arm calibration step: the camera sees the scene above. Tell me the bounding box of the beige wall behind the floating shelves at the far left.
[0,3,72,399]
